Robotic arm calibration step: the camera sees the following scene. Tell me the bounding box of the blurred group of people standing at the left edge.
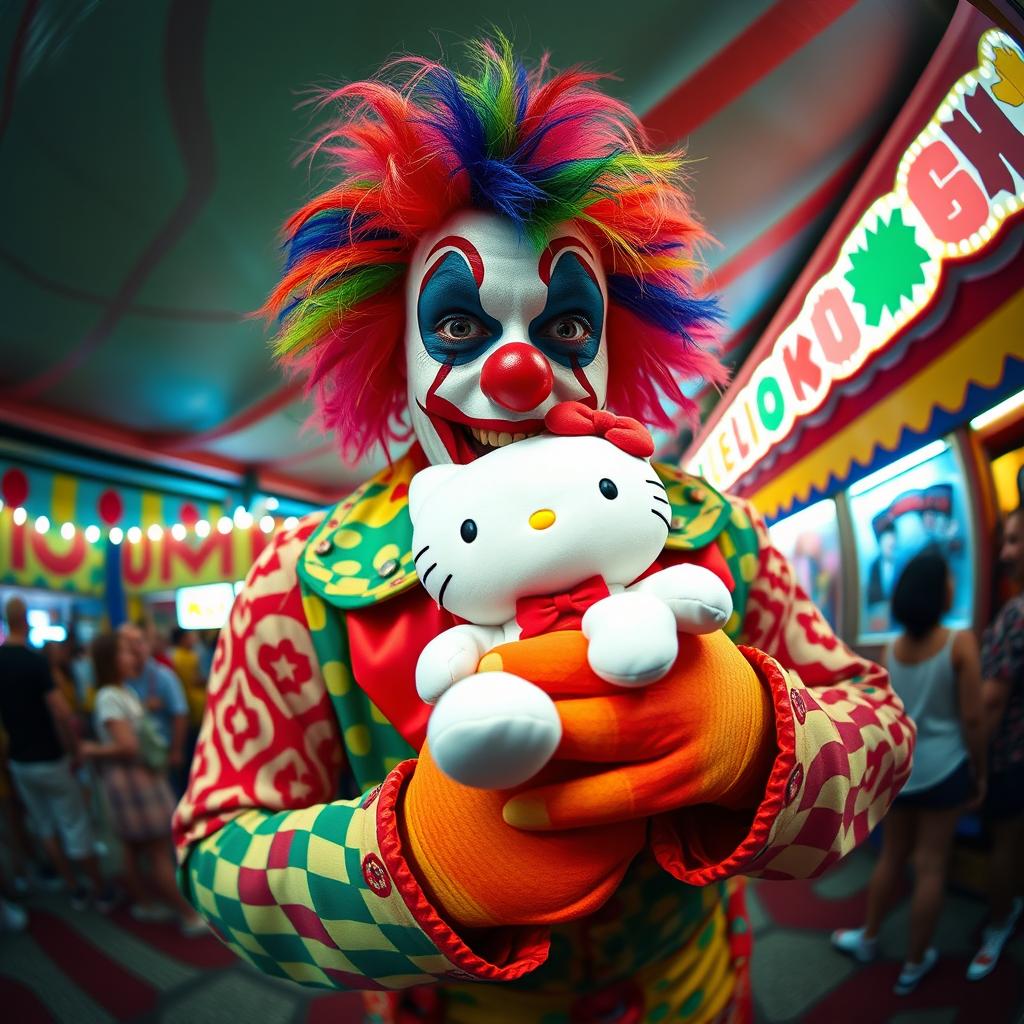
[0,597,209,935]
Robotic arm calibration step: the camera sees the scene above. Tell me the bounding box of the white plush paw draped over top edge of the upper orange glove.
[583,593,679,686]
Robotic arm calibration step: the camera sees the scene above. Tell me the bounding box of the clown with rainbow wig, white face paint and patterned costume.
[175,41,913,1024]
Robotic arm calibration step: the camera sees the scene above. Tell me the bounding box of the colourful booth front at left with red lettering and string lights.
[0,456,309,642]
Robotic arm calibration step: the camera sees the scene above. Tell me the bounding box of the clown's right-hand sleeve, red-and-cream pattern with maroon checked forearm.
[654,499,914,885]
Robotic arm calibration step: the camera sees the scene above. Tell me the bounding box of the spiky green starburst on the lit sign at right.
[846,210,929,327]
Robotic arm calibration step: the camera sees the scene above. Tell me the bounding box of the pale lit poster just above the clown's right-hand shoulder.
[768,499,841,632]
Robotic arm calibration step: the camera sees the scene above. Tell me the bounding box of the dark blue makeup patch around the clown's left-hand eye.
[416,253,502,367]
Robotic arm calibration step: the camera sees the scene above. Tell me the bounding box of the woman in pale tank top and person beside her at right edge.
[833,507,1024,994]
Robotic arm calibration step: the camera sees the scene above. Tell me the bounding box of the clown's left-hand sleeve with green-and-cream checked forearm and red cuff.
[174,521,546,989]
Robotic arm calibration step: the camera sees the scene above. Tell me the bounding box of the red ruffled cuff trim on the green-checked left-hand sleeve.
[377,760,551,981]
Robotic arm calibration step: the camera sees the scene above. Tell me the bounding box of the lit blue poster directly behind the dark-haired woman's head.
[850,442,974,643]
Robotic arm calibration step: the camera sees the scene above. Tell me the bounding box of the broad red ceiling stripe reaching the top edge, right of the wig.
[641,0,856,143]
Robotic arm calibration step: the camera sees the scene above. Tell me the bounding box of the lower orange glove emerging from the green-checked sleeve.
[399,744,646,931]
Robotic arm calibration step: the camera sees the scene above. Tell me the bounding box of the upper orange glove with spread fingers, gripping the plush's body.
[480,632,776,829]
